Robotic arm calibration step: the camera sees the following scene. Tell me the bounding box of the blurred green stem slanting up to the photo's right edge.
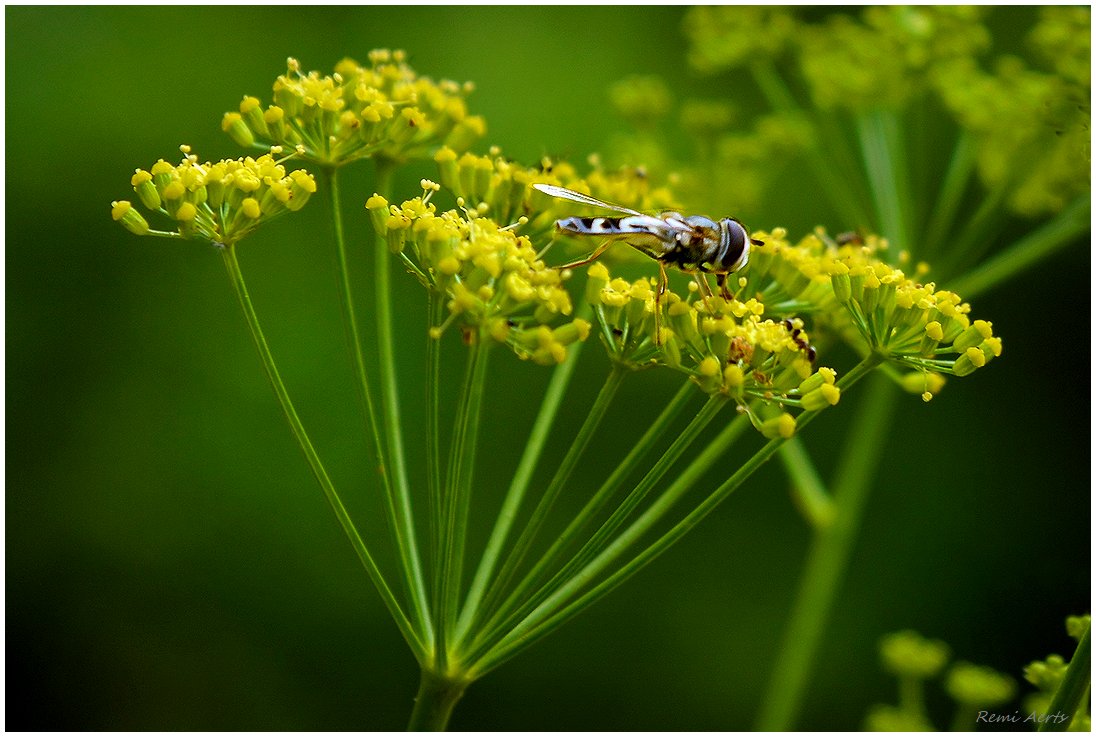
[950,196,1091,299]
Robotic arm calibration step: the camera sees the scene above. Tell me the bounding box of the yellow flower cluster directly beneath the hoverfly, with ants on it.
[586,263,841,438]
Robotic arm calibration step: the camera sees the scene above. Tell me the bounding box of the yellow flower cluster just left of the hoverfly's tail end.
[366,181,590,364]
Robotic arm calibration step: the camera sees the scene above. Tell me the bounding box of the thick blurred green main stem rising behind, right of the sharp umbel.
[757,368,898,732]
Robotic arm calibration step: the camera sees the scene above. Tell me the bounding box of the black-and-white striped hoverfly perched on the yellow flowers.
[533,183,763,343]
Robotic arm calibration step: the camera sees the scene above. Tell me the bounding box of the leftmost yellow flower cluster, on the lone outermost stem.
[112,146,316,246]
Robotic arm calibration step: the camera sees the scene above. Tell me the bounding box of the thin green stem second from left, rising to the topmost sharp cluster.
[326,167,431,642]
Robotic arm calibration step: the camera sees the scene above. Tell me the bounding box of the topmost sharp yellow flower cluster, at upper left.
[221,50,486,166]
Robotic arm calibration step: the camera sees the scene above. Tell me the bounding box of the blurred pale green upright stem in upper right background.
[856,109,913,253]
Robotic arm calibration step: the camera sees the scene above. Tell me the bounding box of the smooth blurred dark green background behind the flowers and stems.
[5,7,1091,730]
